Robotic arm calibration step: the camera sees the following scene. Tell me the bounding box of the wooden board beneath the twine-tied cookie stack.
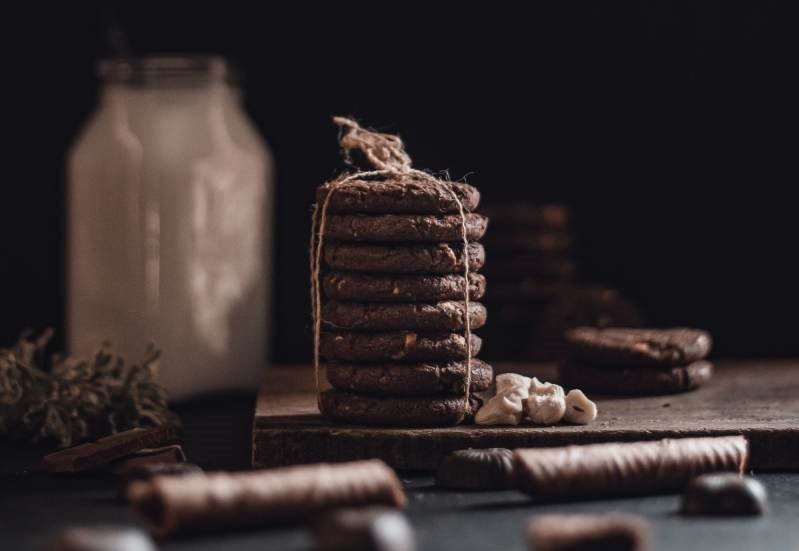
[252,361,799,470]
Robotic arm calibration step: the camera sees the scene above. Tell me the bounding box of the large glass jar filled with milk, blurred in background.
[67,56,273,399]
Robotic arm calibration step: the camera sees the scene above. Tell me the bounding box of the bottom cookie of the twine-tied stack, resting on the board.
[319,390,480,427]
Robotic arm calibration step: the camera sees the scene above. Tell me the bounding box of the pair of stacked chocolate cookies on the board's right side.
[559,327,713,396]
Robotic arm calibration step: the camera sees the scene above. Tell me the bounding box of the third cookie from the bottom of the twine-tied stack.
[319,331,483,362]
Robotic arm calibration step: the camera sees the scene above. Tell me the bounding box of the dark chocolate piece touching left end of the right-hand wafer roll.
[436,448,513,490]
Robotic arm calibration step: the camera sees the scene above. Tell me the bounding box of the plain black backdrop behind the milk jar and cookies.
[0,1,799,361]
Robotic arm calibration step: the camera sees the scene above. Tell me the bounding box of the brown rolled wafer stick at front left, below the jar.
[130,459,405,537]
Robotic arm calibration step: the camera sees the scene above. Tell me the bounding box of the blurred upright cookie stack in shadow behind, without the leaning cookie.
[484,201,576,359]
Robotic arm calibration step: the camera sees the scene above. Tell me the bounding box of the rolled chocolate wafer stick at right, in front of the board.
[513,436,748,500]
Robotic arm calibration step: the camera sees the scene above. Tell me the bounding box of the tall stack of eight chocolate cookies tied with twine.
[316,177,493,426]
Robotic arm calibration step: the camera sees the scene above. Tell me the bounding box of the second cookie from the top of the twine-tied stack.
[325,213,488,243]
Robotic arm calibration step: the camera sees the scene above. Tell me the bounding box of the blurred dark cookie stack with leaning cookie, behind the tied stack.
[484,201,642,360]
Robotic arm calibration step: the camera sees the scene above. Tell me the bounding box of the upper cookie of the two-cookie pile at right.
[566,327,713,367]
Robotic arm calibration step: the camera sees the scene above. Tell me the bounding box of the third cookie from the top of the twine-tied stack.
[324,243,485,274]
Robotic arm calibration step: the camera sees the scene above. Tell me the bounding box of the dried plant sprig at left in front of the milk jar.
[0,329,179,448]
